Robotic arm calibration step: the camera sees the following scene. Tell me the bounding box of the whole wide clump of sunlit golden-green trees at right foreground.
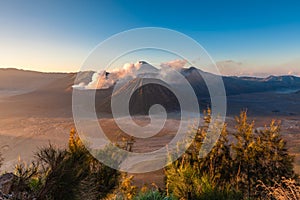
[165,110,296,199]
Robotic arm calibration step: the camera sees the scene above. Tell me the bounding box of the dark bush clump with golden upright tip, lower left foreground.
[37,130,119,200]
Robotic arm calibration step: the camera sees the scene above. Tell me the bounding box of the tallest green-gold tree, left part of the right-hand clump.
[165,109,239,199]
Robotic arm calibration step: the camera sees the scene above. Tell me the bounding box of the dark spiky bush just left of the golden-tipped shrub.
[39,147,89,200]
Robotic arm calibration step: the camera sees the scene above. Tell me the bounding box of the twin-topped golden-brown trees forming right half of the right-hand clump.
[232,112,295,198]
